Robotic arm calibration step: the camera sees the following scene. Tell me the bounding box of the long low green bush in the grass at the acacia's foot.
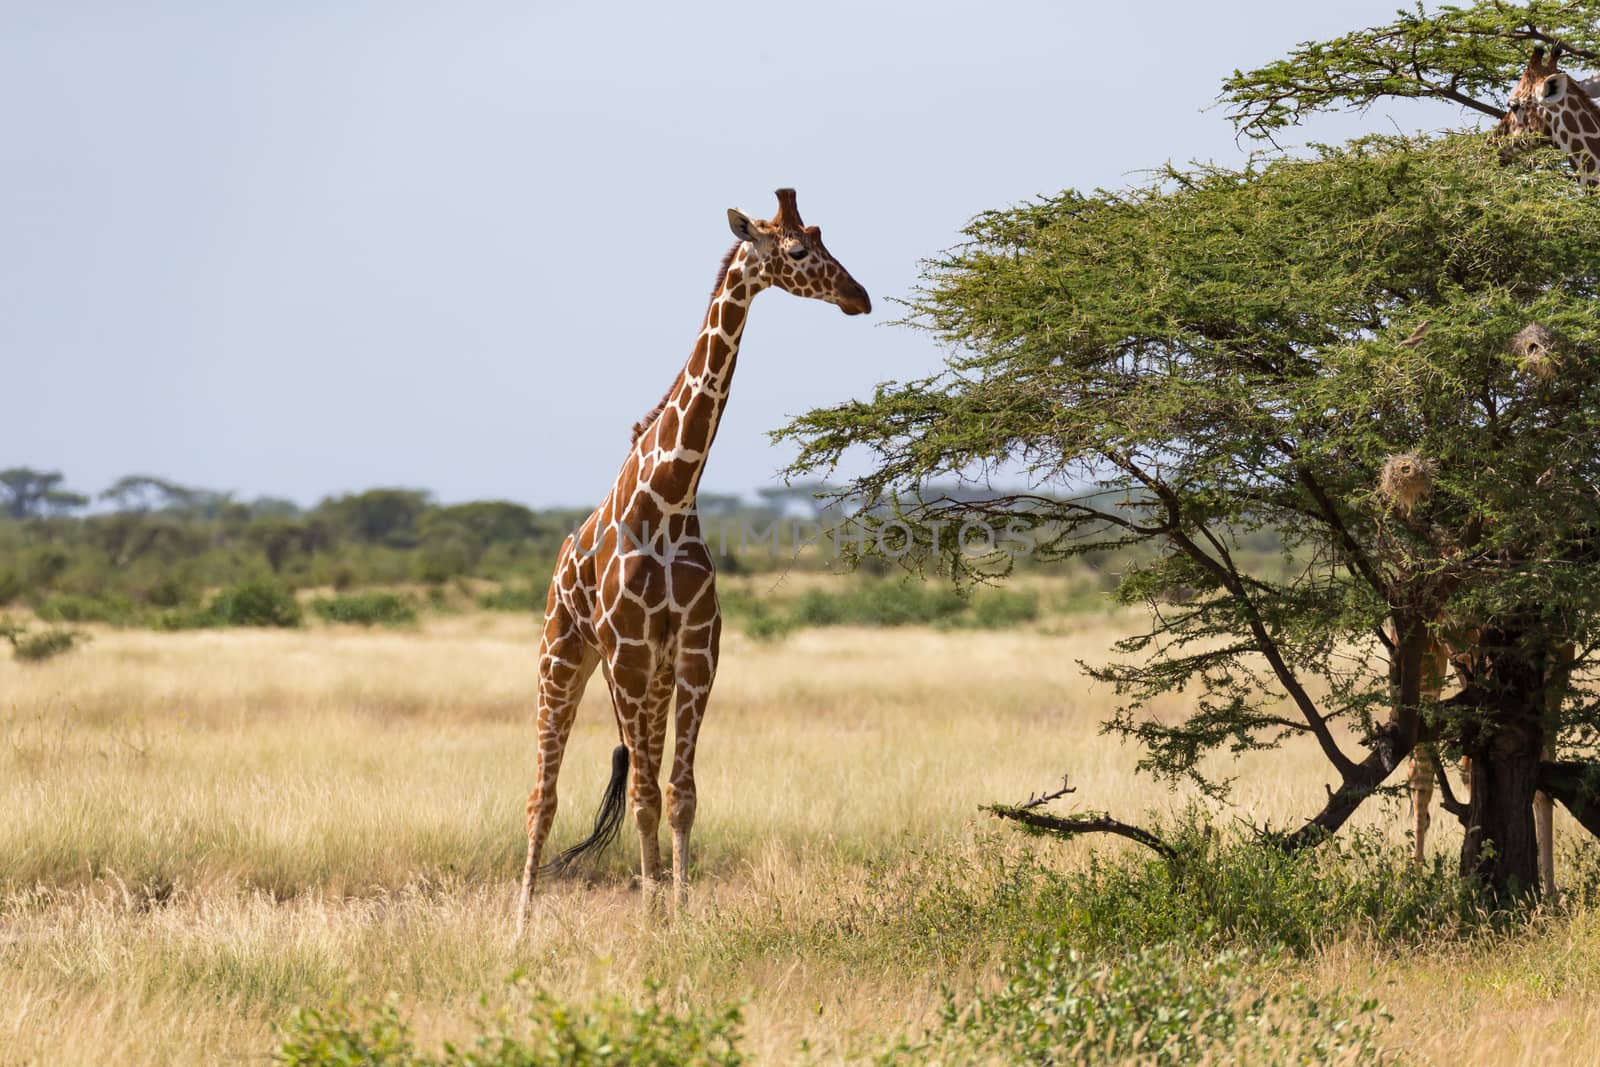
[902,813,1484,957]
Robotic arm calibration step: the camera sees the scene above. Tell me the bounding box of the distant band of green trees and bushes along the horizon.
[0,467,1280,633]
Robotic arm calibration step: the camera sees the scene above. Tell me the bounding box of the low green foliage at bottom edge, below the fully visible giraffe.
[274,987,746,1067]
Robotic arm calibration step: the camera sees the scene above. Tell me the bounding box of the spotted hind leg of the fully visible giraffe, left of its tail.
[517,601,598,939]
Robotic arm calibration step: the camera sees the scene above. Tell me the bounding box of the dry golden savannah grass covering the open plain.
[0,588,1600,1067]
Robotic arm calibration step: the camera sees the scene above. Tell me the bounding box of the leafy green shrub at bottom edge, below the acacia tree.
[880,941,1389,1065]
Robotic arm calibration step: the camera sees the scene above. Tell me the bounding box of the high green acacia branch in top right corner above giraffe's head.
[1222,0,1600,138]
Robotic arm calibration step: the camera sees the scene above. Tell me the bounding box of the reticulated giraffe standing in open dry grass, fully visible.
[517,189,872,936]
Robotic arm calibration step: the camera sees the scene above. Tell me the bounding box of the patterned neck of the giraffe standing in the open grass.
[632,243,763,515]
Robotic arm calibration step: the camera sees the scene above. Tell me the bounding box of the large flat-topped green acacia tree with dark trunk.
[781,136,1600,893]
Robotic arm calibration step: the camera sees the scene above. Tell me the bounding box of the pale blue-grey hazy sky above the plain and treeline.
[0,0,1470,506]
